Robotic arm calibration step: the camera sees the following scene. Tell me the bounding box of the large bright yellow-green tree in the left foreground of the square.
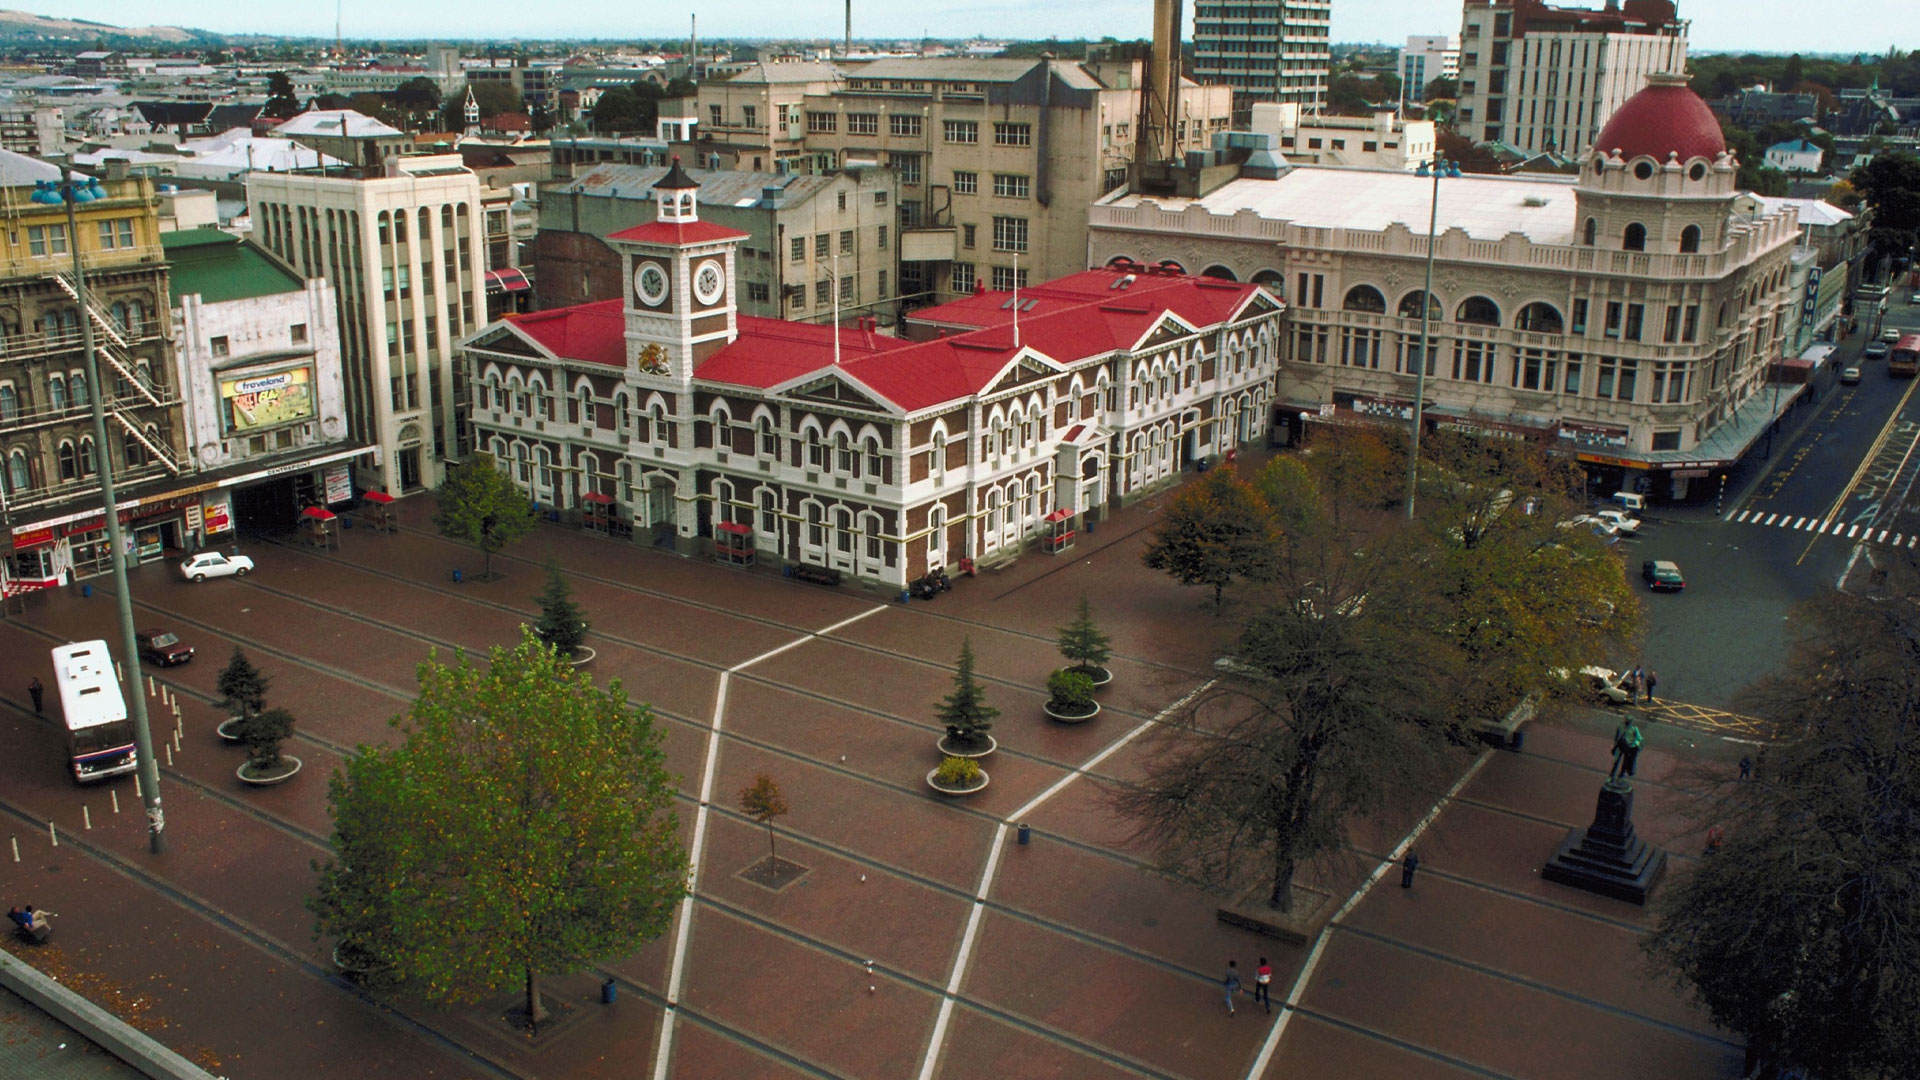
[309,630,687,1026]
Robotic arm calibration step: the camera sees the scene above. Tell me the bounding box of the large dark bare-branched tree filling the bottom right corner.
[1645,553,1920,1080]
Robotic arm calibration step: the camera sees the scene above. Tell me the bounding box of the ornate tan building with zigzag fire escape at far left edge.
[0,161,190,594]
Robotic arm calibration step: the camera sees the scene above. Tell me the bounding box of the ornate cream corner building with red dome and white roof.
[1089,75,1807,502]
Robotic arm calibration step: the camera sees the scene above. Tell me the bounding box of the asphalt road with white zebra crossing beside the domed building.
[1622,290,1920,709]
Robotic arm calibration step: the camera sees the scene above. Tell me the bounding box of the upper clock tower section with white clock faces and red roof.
[607,158,747,382]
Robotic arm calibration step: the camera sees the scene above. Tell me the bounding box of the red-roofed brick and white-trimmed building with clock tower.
[463,169,1281,586]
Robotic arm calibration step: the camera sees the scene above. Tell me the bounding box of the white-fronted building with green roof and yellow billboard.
[161,229,360,526]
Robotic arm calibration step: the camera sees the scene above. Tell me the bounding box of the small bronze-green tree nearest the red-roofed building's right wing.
[1142,465,1273,615]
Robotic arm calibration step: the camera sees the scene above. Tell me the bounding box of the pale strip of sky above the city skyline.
[37,0,1920,54]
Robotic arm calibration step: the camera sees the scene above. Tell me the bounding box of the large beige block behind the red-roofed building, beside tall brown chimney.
[787,60,1233,307]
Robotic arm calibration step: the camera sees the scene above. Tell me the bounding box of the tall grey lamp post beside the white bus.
[33,167,167,855]
